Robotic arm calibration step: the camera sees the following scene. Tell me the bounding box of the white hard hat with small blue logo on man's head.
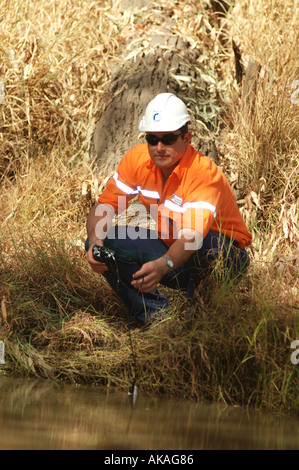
[139,93,190,132]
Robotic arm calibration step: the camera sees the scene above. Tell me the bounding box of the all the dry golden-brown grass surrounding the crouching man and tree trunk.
[0,0,299,409]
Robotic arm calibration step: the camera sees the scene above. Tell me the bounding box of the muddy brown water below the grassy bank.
[0,372,299,451]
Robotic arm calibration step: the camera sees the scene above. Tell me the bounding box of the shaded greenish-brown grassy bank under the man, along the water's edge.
[1,233,298,411]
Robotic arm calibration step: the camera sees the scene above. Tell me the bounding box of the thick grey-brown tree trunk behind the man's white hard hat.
[91,0,217,172]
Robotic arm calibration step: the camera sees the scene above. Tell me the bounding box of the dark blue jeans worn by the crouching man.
[85,226,249,324]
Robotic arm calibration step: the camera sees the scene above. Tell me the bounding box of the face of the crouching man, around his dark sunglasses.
[147,130,191,177]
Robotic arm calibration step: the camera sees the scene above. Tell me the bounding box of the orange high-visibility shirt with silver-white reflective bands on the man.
[99,144,252,247]
